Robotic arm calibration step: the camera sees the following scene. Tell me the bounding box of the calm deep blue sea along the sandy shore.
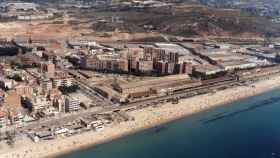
[58,89,280,158]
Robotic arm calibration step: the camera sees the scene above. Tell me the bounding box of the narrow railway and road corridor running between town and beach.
[12,69,279,133]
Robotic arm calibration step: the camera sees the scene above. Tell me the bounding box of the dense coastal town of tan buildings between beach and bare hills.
[0,34,280,146]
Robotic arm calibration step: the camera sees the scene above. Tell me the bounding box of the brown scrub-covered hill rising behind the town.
[88,4,280,37]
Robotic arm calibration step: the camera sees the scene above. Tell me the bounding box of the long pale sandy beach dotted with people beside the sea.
[0,77,280,158]
